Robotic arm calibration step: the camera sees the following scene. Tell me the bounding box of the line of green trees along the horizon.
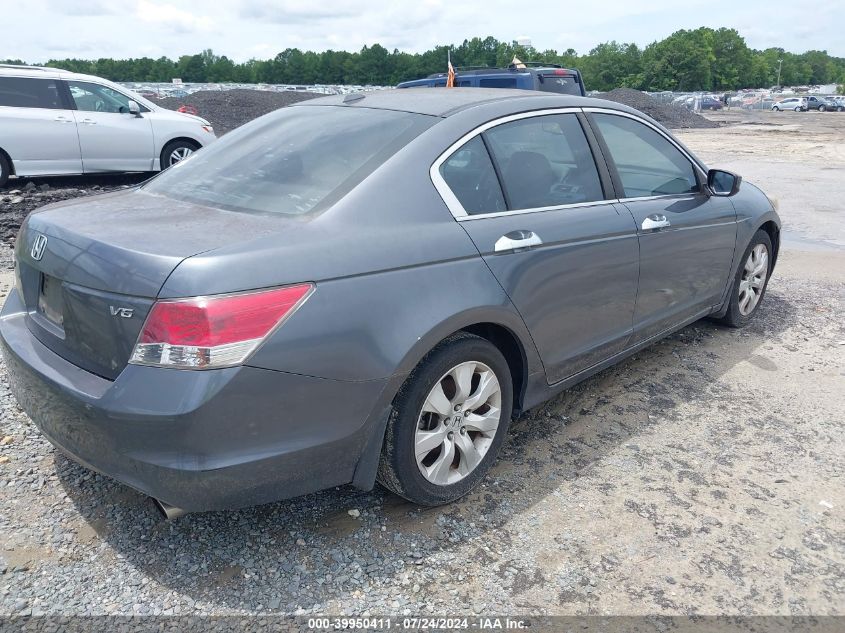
[6,27,845,91]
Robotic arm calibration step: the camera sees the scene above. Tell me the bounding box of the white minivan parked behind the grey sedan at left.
[0,65,217,187]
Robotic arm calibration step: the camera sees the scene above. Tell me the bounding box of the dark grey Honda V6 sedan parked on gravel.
[0,88,780,513]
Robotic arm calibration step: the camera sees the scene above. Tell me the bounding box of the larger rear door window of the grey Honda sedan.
[485,114,604,209]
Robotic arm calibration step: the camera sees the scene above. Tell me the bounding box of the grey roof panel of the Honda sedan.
[294,88,636,117]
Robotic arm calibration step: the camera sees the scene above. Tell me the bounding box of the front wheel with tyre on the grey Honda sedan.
[721,230,772,327]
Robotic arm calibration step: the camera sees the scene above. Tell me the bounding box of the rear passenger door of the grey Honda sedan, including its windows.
[432,110,639,383]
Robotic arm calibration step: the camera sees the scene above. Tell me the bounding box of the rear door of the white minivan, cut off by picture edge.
[0,77,82,176]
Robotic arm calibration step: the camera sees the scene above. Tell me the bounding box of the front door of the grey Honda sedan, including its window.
[591,113,736,343]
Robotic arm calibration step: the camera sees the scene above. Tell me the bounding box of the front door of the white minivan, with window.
[67,81,155,173]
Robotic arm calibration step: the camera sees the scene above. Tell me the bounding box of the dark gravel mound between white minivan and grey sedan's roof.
[152,89,325,136]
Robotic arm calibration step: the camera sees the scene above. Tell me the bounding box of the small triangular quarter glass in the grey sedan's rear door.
[440,136,507,215]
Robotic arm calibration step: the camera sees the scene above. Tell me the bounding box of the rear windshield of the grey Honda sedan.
[142,106,437,215]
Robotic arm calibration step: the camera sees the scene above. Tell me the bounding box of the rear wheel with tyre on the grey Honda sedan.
[378,333,513,506]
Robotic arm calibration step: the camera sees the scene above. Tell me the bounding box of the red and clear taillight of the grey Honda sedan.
[129,284,314,369]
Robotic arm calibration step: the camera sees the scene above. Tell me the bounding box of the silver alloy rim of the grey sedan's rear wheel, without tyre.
[414,361,502,486]
